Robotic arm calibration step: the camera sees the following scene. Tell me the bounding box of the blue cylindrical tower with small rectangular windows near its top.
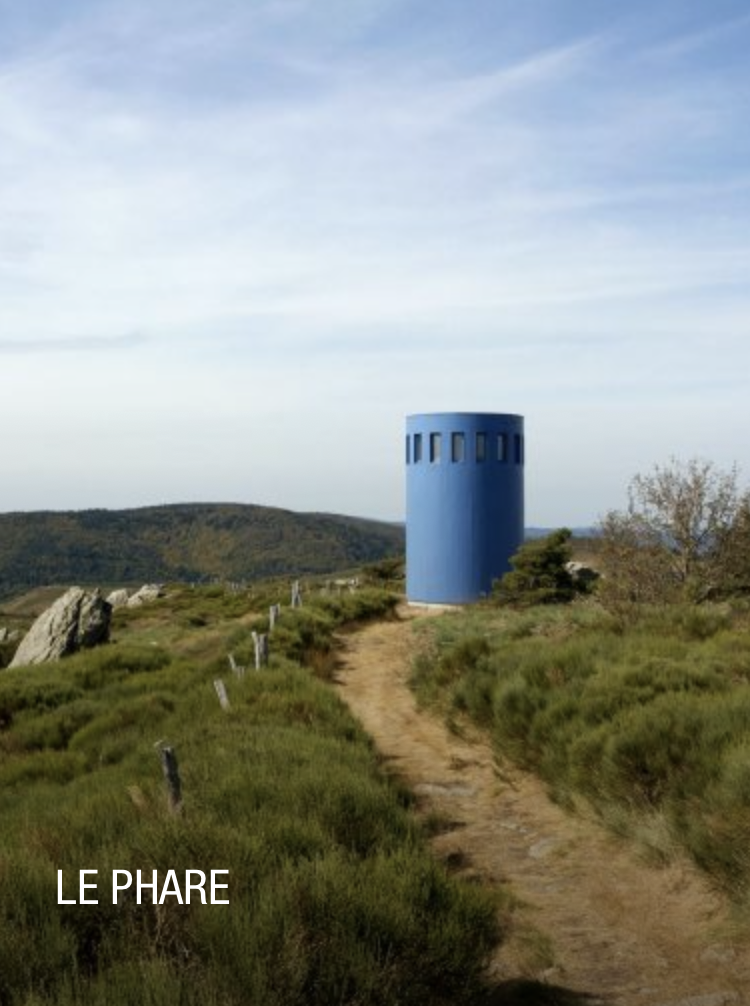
[406,412,524,604]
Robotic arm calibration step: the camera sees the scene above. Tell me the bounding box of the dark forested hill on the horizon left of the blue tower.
[0,503,404,596]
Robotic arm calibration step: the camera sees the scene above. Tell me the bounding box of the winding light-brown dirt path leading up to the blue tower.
[337,621,750,1006]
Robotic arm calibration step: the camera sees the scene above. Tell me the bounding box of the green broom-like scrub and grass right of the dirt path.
[412,603,750,907]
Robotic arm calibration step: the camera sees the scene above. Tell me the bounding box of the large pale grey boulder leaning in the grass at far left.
[10,586,112,667]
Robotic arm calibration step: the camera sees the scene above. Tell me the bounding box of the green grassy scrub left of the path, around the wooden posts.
[0,588,498,1006]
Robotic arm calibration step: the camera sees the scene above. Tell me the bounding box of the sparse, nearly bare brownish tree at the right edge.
[599,459,750,607]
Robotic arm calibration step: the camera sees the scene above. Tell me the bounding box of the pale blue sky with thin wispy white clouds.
[0,0,750,526]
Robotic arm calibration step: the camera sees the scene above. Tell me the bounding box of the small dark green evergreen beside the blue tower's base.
[494,527,581,606]
